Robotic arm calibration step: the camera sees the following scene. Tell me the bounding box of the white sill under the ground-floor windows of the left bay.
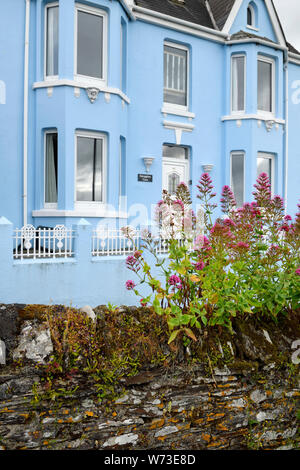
[32,208,128,219]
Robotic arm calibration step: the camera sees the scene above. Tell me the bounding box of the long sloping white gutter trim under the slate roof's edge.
[133,5,228,43]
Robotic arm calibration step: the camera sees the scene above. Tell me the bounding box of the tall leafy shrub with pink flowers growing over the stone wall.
[126,173,300,342]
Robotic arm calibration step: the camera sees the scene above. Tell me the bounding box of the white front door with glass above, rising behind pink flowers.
[162,146,189,194]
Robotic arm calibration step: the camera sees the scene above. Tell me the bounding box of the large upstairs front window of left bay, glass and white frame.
[75,5,107,80]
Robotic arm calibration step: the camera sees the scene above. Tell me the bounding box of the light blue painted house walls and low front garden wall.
[0,0,300,305]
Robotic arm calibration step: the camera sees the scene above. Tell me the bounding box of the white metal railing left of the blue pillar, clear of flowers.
[13,225,74,260]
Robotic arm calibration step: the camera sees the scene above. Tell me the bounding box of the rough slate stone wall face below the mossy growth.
[0,307,300,450]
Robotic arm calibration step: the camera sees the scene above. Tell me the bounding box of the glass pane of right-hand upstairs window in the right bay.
[257,60,273,112]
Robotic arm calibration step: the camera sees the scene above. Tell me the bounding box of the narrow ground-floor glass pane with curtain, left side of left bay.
[45,133,58,203]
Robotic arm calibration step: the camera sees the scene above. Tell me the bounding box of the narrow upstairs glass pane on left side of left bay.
[46,7,58,76]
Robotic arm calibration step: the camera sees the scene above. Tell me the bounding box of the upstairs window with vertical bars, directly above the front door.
[164,43,188,107]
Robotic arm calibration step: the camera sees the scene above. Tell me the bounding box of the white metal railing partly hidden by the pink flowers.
[92,228,140,256]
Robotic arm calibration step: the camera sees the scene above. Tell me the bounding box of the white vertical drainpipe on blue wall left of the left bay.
[23,0,30,225]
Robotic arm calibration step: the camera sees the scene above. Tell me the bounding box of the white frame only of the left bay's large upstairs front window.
[74,3,108,86]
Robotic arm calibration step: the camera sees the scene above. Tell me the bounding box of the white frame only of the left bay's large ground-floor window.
[74,130,108,210]
